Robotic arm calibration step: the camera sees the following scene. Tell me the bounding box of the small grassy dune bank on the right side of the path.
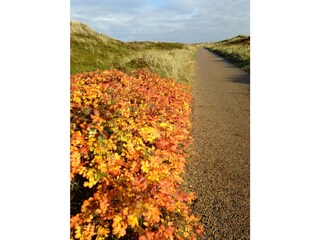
[203,35,250,72]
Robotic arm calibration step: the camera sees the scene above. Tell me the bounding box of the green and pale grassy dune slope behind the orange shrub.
[70,22,196,83]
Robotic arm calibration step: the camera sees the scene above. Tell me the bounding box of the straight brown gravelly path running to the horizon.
[186,48,250,240]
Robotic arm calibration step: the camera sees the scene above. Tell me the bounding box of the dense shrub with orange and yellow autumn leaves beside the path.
[70,70,203,240]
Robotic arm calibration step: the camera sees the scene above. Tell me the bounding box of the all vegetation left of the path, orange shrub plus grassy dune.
[70,22,203,240]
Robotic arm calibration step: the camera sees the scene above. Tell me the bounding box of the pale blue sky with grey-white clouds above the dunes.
[71,0,250,43]
